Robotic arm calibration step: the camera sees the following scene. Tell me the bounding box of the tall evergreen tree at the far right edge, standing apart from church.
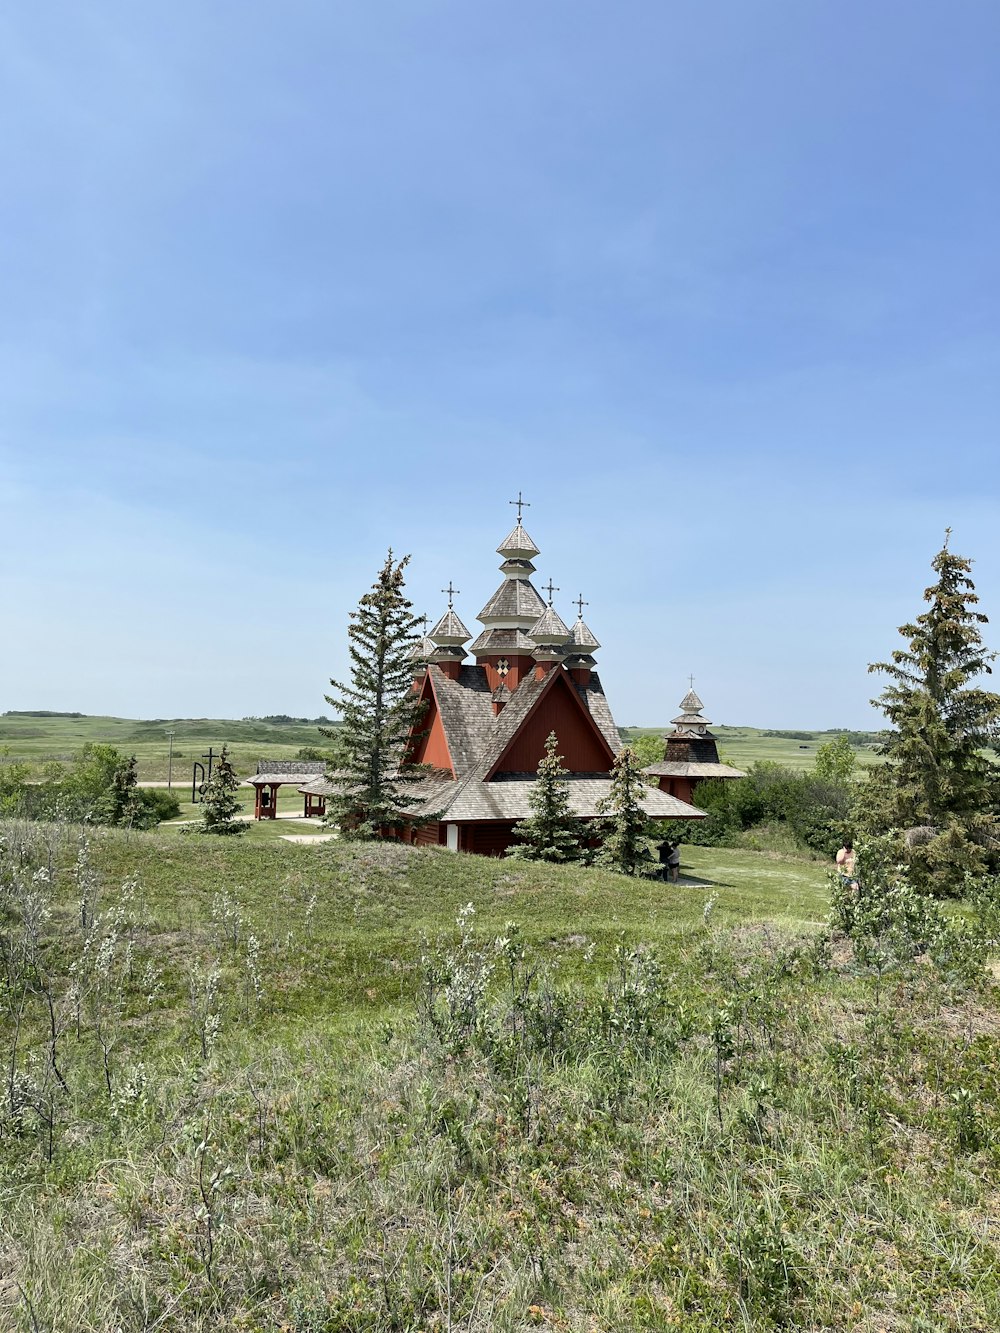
[857,529,1000,893]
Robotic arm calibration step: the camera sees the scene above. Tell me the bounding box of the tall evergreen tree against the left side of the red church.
[324,548,424,838]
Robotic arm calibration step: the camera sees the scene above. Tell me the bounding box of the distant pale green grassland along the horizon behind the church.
[0,713,876,790]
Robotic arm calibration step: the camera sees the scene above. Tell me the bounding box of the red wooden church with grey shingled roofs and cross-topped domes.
[309,501,703,856]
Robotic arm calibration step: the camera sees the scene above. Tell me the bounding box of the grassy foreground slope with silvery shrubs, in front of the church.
[0,820,1000,1333]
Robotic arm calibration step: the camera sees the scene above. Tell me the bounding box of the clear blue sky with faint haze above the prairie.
[0,0,1000,726]
